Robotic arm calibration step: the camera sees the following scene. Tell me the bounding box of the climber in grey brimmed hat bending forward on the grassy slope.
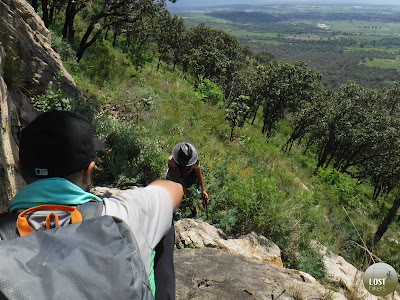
[166,142,208,201]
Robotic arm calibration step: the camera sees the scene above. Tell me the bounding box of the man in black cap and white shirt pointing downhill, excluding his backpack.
[5,111,183,296]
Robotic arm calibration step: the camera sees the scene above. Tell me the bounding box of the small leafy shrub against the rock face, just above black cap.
[31,73,72,113]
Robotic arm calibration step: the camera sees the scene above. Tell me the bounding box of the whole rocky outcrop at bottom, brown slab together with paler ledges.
[174,219,400,300]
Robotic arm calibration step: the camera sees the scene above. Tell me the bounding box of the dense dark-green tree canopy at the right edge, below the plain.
[288,82,400,198]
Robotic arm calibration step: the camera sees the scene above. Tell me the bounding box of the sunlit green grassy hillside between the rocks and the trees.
[48,26,400,280]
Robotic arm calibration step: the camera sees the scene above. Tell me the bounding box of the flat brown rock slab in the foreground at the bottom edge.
[174,247,346,300]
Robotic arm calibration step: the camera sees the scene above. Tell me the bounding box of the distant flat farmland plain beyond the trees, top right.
[171,4,400,88]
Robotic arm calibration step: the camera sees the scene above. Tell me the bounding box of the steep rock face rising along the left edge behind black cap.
[0,0,78,210]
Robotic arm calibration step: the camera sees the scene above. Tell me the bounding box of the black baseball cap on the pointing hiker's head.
[19,110,104,178]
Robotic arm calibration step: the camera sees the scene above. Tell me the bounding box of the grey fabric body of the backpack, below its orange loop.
[0,203,153,300]
